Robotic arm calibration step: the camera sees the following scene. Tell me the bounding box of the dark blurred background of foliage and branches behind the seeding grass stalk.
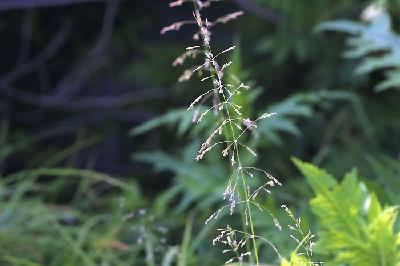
[0,0,400,265]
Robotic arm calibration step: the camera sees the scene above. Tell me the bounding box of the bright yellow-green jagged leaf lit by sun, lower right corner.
[293,159,400,266]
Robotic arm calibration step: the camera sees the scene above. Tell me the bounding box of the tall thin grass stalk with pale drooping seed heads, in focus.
[161,0,313,265]
